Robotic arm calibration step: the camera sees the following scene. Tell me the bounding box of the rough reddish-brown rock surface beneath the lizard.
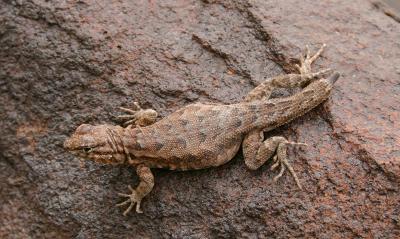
[0,0,400,238]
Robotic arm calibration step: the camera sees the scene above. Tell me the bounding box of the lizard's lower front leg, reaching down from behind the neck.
[117,165,154,216]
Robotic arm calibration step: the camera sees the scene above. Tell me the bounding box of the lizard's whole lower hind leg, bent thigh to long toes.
[243,130,306,189]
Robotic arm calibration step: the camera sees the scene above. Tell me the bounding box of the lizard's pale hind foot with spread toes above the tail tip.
[295,43,332,79]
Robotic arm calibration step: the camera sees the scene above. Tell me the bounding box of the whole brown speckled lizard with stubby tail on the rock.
[64,44,340,215]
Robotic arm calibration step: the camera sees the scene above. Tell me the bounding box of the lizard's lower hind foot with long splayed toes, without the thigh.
[271,141,307,189]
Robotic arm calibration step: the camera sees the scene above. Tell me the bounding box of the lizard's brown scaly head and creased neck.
[64,124,126,164]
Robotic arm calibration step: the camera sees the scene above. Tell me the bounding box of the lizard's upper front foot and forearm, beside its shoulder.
[118,102,158,127]
